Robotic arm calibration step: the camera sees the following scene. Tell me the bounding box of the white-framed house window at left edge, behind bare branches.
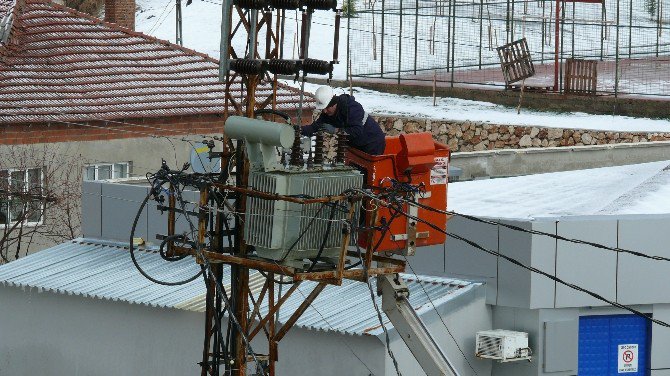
[0,168,44,226]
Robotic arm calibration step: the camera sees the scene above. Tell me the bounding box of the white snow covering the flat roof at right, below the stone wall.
[449,161,670,219]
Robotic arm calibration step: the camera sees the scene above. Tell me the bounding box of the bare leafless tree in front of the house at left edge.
[0,144,83,264]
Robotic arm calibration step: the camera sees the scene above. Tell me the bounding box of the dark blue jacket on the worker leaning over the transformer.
[302,94,386,155]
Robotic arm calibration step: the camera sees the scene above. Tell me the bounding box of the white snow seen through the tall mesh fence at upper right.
[351,0,670,85]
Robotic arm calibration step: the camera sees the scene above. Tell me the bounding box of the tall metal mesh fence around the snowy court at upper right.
[345,0,670,96]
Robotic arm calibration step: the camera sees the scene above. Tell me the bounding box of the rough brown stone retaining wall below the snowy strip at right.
[375,115,670,152]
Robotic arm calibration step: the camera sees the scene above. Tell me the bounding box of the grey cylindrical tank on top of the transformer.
[223,116,294,148]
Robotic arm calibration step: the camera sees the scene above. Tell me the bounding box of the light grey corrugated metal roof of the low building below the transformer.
[0,239,480,335]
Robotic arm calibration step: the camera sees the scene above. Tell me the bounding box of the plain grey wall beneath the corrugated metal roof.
[0,287,386,376]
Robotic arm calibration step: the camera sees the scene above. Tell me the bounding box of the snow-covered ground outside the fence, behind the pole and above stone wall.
[136,0,670,132]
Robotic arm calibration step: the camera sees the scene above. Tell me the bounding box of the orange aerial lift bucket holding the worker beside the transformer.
[346,132,450,255]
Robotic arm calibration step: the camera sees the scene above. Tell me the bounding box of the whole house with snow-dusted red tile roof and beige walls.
[0,0,312,263]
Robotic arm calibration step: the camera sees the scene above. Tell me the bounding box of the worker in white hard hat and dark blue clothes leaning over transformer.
[302,86,386,155]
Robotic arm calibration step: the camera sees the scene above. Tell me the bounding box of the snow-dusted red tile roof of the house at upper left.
[0,0,311,123]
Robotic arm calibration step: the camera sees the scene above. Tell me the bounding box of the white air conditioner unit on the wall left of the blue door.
[475,329,532,362]
